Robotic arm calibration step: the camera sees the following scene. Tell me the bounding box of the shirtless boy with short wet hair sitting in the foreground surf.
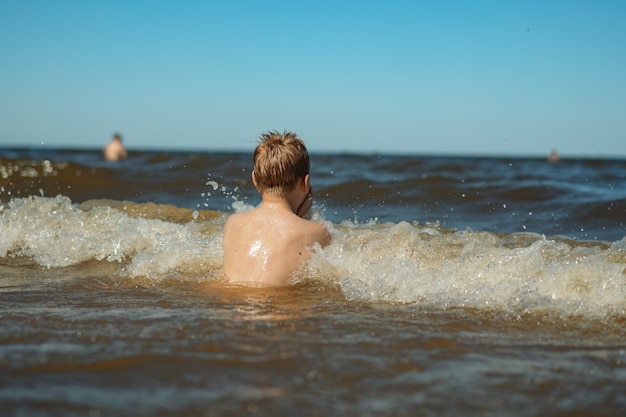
[222,131,330,286]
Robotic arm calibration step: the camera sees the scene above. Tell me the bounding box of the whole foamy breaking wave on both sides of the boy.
[0,195,626,318]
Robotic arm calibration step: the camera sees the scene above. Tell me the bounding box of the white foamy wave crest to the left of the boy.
[0,196,223,278]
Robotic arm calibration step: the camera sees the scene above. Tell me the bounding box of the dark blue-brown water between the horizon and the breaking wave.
[0,149,626,241]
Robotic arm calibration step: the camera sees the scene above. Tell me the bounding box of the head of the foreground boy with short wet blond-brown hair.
[253,131,310,196]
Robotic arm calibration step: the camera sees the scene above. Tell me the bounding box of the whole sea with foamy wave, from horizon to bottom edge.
[0,147,626,417]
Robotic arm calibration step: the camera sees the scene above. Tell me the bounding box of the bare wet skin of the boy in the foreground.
[222,174,330,286]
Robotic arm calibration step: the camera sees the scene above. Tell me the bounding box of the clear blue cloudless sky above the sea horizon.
[0,0,626,158]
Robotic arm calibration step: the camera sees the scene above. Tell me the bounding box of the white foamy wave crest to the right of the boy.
[309,222,626,317]
